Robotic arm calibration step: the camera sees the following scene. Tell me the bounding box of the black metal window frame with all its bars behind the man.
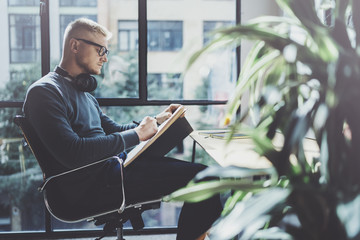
[0,0,241,239]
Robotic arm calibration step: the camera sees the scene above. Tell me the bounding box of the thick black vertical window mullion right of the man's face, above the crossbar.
[138,0,148,102]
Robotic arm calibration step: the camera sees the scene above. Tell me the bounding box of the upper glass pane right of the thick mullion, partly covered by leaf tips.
[147,0,236,100]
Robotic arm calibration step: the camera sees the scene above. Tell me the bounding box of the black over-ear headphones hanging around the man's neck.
[54,66,97,92]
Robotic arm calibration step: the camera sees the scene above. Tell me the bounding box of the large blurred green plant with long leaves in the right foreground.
[166,0,360,240]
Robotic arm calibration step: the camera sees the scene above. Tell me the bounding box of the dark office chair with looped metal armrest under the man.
[14,115,161,240]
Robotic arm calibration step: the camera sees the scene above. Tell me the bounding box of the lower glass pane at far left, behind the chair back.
[0,108,45,232]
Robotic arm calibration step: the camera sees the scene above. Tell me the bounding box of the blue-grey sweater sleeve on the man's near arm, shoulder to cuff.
[23,86,139,168]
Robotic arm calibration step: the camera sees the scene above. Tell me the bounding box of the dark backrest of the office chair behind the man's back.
[14,115,69,179]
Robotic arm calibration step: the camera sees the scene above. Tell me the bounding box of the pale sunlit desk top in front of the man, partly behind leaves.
[190,130,319,169]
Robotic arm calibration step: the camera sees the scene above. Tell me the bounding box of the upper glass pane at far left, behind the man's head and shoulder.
[0,13,41,101]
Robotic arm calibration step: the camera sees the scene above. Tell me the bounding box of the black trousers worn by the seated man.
[110,157,222,240]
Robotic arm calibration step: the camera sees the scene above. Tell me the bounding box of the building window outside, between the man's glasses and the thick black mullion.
[118,20,139,51]
